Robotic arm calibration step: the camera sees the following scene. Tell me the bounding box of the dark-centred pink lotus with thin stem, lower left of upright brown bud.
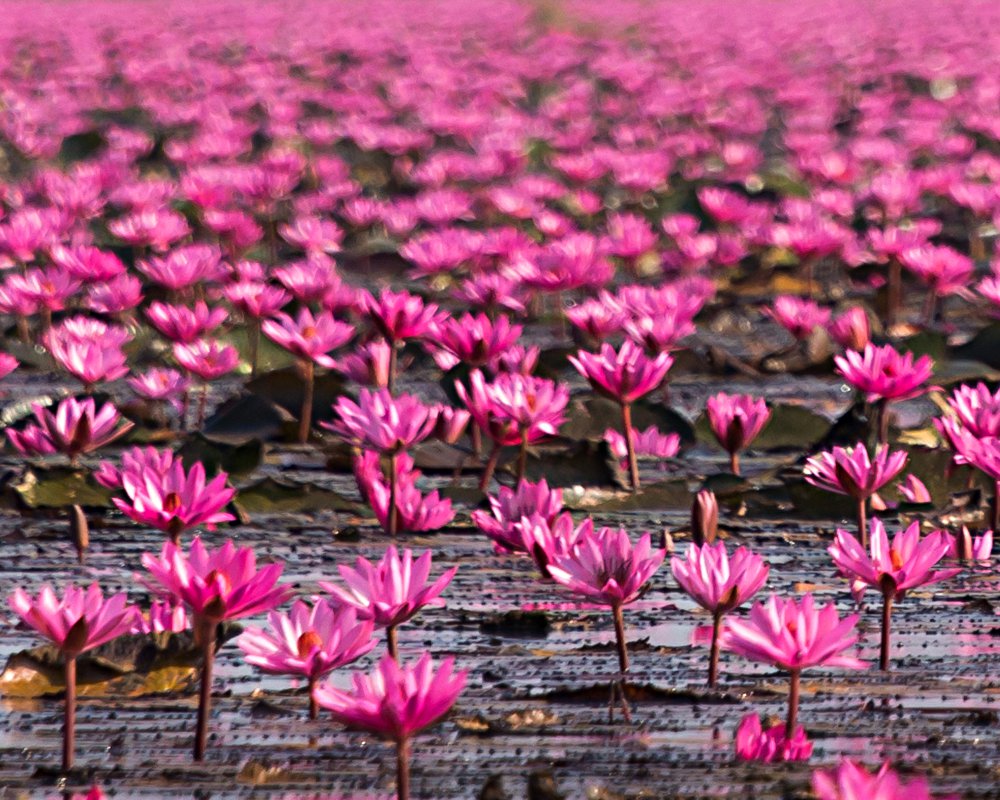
[548,527,667,721]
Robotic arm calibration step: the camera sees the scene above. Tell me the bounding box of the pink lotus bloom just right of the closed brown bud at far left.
[111,458,236,544]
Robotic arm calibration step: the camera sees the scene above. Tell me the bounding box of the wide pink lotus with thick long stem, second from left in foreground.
[142,536,291,761]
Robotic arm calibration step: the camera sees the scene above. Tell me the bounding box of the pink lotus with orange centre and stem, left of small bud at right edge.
[828,519,961,671]
